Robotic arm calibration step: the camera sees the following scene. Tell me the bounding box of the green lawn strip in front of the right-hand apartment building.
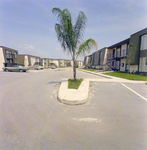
[103,72,147,81]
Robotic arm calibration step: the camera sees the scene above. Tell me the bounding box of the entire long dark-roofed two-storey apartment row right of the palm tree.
[84,28,147,75]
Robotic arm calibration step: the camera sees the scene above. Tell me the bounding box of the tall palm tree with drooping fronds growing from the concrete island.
[52,8,97,81]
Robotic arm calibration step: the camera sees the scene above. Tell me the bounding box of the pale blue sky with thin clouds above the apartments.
[0,0,147,60]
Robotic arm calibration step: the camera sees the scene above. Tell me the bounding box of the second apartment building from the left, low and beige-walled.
[18,54,41,67]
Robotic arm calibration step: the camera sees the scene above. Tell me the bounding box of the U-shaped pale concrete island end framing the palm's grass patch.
[57,79,89,105]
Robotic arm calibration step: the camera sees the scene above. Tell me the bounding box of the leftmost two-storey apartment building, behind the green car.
[0,46,19,70]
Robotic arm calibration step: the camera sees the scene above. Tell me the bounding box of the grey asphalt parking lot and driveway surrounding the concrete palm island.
[0,68,147,150]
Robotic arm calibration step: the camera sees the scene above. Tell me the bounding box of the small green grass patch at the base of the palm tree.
[68,79,83,89]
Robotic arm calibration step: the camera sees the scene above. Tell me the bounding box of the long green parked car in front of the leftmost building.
[2,65,29,72]
